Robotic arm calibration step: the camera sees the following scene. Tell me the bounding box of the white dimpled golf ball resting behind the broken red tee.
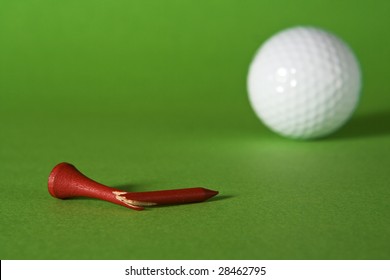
[248,27,361,139]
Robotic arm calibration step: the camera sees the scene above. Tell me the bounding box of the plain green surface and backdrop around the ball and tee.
[0,0,390,259]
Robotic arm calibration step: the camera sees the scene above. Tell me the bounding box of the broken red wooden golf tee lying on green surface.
[48,162,218,210]
